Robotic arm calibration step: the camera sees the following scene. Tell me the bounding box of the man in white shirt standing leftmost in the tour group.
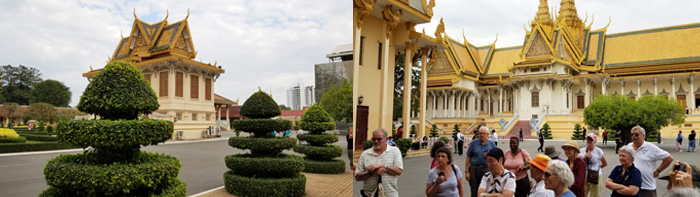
[355,128,403,197]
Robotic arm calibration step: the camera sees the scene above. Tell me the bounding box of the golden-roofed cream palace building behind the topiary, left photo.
[83,13,227,139]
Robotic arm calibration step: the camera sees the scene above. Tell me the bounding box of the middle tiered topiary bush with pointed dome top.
[224,91,306,196]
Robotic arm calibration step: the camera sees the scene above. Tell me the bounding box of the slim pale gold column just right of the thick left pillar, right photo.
[402,41,416,138]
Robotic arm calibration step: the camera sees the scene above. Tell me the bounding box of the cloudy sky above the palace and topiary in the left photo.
[0,0,352,107]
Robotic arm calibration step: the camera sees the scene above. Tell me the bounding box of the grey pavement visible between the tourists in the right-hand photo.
[353,138,700,197]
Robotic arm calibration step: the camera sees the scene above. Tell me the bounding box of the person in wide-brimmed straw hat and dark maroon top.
[561,140,586,196]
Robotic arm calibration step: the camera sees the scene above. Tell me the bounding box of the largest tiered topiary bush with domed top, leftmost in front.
[42,61,187,196]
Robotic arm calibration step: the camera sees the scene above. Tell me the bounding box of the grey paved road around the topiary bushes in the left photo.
[0,132,349,197]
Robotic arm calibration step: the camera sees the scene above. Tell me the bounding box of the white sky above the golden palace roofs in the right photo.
[416,0,700,48]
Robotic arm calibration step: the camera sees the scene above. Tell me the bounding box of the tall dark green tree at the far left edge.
[0,65,41,105]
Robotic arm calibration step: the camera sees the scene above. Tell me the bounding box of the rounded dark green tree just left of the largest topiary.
[29,79,71,107]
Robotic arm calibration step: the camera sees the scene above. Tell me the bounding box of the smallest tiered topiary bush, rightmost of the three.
[294,104,345,174]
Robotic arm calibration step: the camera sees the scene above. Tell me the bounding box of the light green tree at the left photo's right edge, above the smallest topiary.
[321,79,352,122]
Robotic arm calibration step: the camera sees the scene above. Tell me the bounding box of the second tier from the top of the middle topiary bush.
[233,119,292,138]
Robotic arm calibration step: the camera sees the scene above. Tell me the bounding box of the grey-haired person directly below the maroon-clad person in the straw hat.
[542,160,576,197]
